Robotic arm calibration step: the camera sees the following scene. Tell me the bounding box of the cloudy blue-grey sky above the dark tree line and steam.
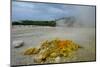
[12,1,95,20]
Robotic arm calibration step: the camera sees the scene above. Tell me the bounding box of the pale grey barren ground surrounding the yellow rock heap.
[11,26,95,65]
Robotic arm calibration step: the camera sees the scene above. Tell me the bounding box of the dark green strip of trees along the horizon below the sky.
[12,20,56,26]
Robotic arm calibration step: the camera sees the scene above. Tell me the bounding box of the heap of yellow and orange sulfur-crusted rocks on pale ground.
[24,39,80,63]
